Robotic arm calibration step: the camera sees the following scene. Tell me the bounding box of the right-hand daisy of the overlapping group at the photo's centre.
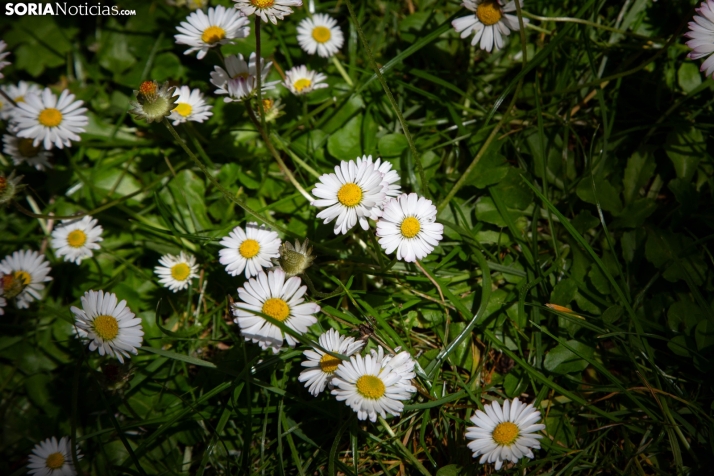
[377,193,444,262]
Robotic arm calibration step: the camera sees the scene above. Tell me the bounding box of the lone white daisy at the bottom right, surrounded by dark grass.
[466,398,545,471]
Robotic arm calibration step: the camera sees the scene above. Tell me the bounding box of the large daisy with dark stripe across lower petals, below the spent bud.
[233,269,320,354]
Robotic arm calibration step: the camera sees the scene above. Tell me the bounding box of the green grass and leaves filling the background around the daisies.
[0,0,714,476]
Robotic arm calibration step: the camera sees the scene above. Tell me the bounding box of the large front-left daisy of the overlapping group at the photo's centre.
[312,160,385,235]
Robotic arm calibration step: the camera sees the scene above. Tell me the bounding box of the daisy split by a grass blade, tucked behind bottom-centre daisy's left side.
[298,329,364,397]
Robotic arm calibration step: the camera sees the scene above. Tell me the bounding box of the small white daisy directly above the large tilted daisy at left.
[52,215,104,264]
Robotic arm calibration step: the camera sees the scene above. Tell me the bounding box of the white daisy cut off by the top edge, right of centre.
[451,0,528,53]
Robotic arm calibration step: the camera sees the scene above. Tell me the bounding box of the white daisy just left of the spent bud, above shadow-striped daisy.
[218,222,280,278]
